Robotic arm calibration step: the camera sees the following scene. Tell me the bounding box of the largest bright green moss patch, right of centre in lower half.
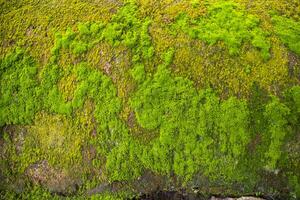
[131,62,250,181]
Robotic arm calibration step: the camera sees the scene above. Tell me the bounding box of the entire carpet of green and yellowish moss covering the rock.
[0,0,300,199]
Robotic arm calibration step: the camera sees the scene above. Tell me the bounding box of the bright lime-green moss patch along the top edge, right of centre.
[171,1,270,59]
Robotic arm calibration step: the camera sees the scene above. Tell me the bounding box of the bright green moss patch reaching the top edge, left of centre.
[51,1,154,65]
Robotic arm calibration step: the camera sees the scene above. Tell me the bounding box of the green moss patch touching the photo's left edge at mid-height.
[0,49,40,126]
